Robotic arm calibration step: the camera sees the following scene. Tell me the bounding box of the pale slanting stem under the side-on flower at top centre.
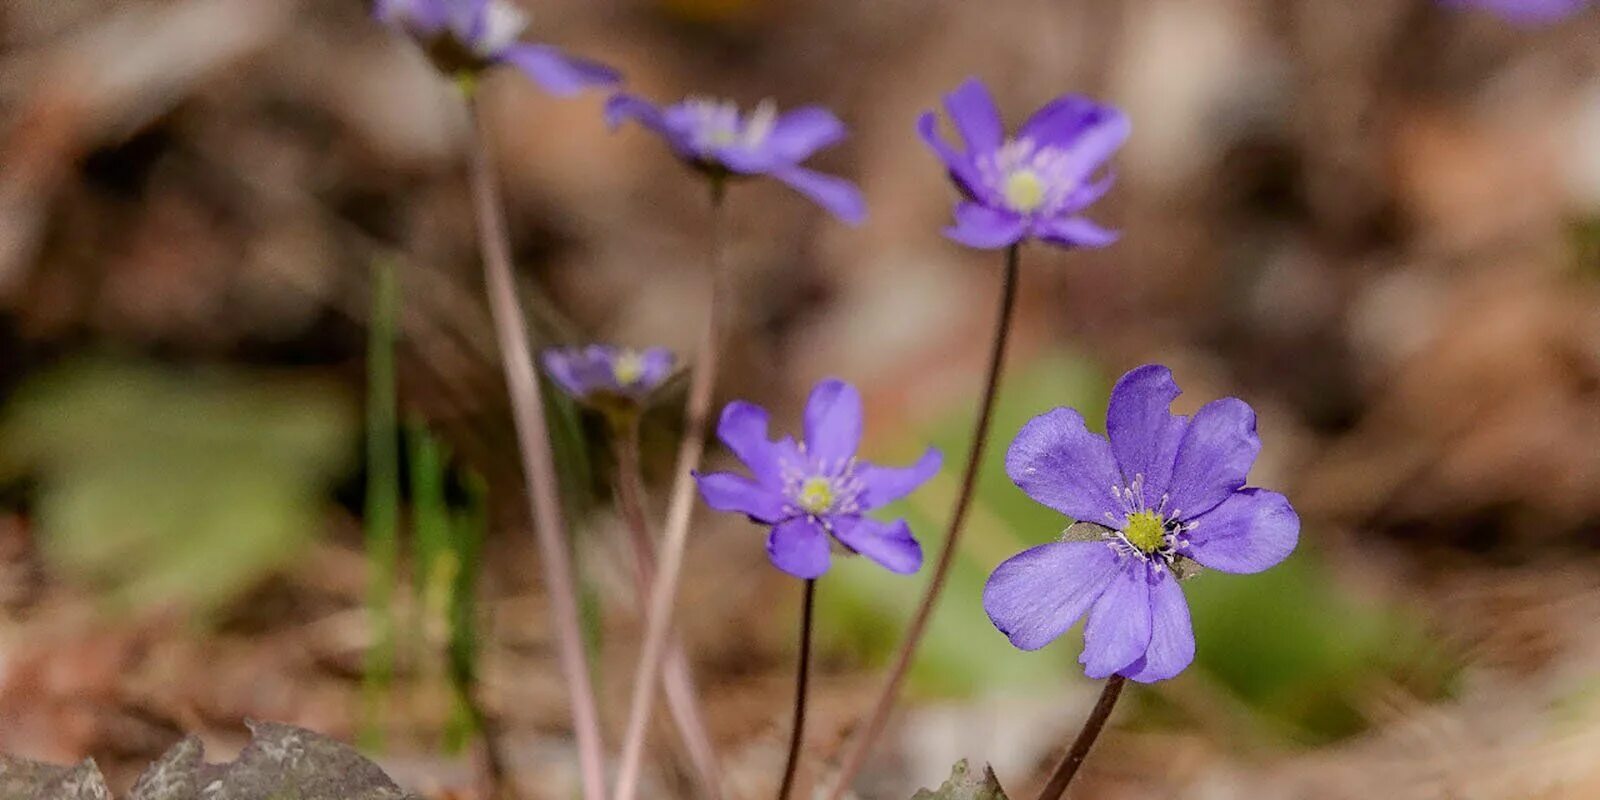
[613,179,728,800]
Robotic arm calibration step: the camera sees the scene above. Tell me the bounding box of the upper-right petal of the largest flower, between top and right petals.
[1168,397,1261,520]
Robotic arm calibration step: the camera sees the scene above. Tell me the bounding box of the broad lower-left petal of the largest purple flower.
[984,542,1118,650]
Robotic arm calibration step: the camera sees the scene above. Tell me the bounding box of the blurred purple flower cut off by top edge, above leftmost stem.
[373,0,621,96]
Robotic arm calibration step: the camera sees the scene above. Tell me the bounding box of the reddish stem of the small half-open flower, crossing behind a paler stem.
[611,414,722,800]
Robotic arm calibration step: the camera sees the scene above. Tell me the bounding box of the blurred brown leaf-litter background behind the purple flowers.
[0,0,1600,800]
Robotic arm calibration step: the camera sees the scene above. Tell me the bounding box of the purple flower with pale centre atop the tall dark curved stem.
[917,78,1130,250]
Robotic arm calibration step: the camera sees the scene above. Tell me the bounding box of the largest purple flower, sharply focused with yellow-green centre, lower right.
[984,365,1299,683]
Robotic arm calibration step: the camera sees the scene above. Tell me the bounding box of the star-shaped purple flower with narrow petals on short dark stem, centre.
[694,381,942,579]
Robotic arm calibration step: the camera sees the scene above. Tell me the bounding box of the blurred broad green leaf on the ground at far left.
[0,362,354,614]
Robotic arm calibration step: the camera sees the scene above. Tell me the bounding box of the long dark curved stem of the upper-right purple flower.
[829,245,1021,800]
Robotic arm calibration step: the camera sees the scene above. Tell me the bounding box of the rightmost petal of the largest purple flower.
[1184,490,1299,573]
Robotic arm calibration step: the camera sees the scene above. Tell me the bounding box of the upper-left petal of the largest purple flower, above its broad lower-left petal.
[1005,408,1122,523]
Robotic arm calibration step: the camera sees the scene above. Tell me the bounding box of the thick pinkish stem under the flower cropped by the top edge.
[469,87,605,800]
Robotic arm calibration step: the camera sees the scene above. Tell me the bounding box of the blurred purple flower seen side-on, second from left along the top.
[605,94,867,226]
